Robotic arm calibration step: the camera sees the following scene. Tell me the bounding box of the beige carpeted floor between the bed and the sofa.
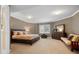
[11,38,78,54]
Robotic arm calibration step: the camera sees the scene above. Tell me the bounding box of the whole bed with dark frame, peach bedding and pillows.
[11,29,40,45]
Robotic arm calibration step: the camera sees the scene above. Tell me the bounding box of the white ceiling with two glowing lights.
[10,5,79,23]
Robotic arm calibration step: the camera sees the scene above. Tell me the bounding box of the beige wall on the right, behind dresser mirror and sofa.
[54,13,79,34]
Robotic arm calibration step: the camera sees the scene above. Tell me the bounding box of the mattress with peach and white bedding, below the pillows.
[12,34,39,40]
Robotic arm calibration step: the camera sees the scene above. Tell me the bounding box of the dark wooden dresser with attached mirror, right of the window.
[51,24,67,40]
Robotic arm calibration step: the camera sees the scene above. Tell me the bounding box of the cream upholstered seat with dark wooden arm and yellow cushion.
[61,34,79,51]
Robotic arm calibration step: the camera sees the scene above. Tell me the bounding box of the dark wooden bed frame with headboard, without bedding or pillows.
[11,29,40,45]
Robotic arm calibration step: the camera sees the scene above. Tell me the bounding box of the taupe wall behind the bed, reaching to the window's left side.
[10,17,38,34]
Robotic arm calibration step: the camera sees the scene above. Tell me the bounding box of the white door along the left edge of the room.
[0,5,10,53]
